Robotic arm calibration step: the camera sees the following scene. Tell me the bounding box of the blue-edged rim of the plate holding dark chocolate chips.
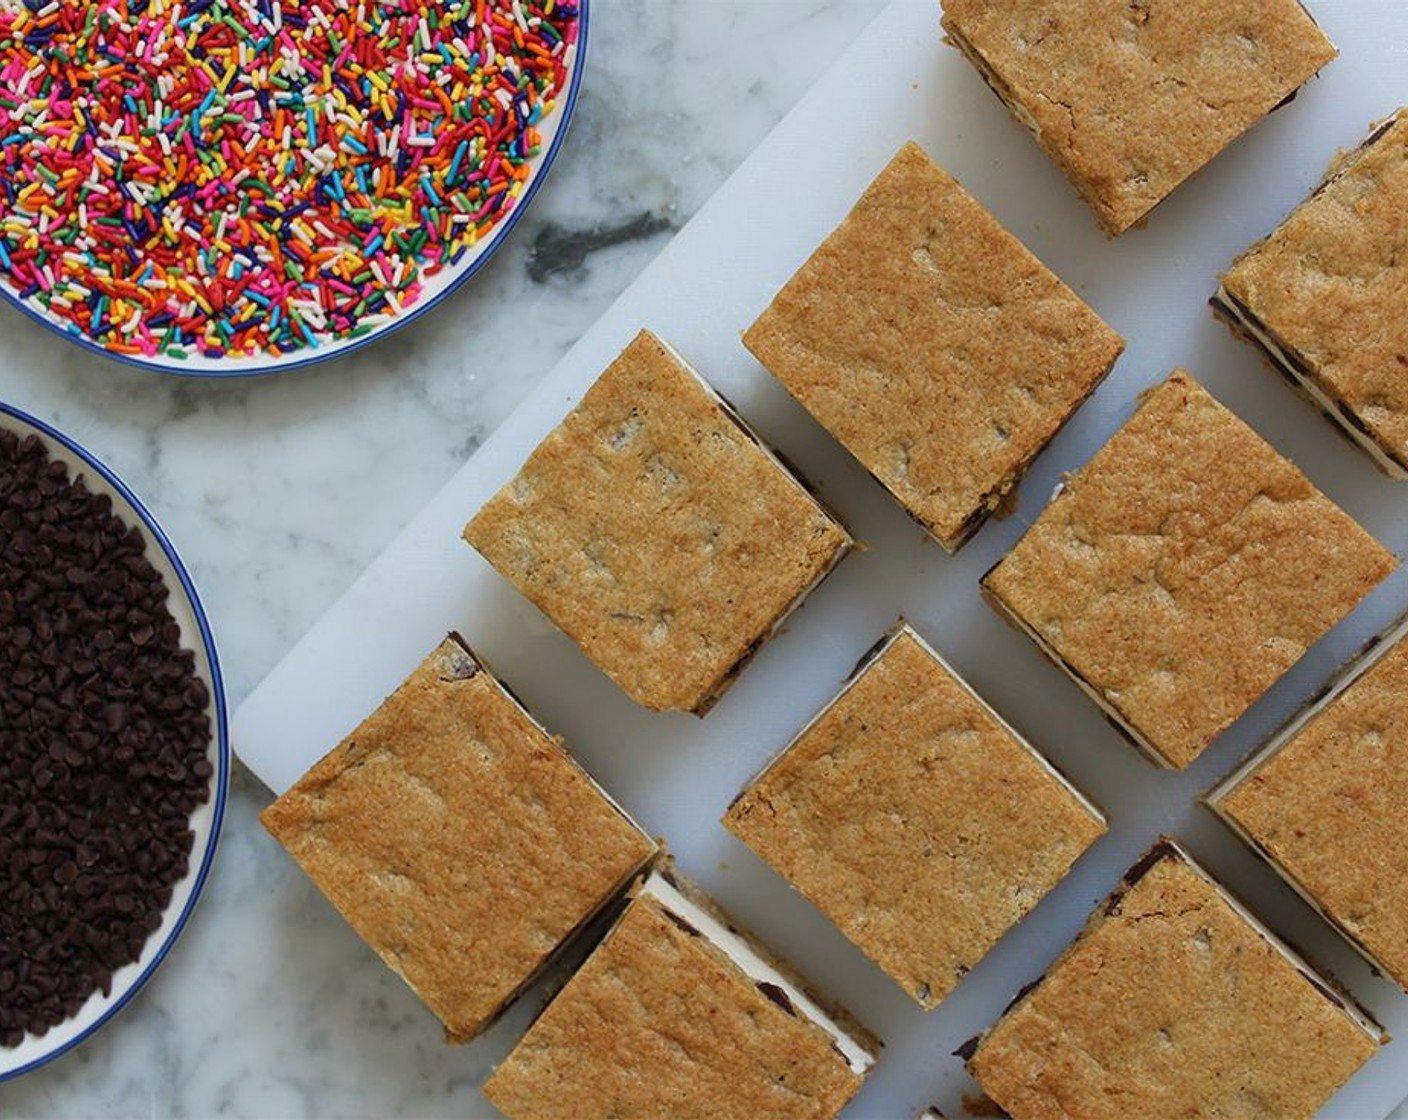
[0,400,230,1083]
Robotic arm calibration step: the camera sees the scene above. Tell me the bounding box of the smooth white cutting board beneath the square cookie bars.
[234,0,1408,1120]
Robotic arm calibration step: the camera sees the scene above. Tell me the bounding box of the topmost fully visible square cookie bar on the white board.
[743,144,1124,552]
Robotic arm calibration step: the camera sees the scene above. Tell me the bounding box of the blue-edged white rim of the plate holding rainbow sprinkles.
[0,0,591,380]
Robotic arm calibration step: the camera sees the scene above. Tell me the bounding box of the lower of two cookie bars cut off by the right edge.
[1208,620,1408,989]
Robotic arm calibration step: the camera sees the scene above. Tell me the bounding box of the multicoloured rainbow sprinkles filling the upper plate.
[0,0,579,359]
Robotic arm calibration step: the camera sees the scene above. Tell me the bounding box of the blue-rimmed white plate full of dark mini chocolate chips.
[0,403,230,1081]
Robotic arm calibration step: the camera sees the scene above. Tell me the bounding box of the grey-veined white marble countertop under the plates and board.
[0,0,883,1117]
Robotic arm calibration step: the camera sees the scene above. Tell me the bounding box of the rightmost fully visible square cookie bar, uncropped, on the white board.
[983,371,1397,766]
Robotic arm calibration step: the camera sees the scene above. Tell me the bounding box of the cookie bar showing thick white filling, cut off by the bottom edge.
[484,869,880,1120]
